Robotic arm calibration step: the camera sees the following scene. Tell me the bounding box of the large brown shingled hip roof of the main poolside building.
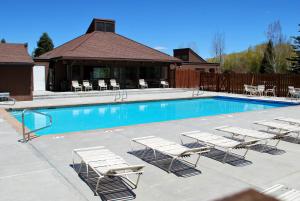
[38,31,181,62]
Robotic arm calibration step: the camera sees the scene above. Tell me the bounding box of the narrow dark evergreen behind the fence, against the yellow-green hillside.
[259,40,274,73]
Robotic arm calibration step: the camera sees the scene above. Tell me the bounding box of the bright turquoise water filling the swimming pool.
[12,97,290,135]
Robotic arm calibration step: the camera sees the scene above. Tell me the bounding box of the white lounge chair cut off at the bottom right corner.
[262,184,300,201]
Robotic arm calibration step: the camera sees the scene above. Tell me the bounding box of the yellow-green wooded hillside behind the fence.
[208,43,293,73]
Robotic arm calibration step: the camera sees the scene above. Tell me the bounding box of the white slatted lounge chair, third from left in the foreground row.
[181,131,258,163]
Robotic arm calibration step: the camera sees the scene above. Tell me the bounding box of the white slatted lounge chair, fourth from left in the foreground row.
[216,126,284,148]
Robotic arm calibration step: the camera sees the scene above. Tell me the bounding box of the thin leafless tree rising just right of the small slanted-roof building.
[212,32,225,66]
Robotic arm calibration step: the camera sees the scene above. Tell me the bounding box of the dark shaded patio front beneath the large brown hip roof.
[47,60,174,91]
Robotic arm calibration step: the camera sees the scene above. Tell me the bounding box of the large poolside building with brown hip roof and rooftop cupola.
[35,19,181,91]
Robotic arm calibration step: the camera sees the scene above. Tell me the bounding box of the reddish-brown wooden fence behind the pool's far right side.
[171,69,300,96]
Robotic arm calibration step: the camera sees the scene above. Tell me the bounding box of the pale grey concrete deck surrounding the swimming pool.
[0,91,300,201]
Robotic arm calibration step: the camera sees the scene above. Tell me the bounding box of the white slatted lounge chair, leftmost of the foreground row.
[72,146,144,195]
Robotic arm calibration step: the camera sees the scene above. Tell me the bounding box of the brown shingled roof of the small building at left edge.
[0,43,33,64]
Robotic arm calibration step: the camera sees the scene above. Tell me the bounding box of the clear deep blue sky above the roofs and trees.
[0,0,300,58]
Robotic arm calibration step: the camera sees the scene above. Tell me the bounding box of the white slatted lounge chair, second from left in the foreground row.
[131,136,210,173]
